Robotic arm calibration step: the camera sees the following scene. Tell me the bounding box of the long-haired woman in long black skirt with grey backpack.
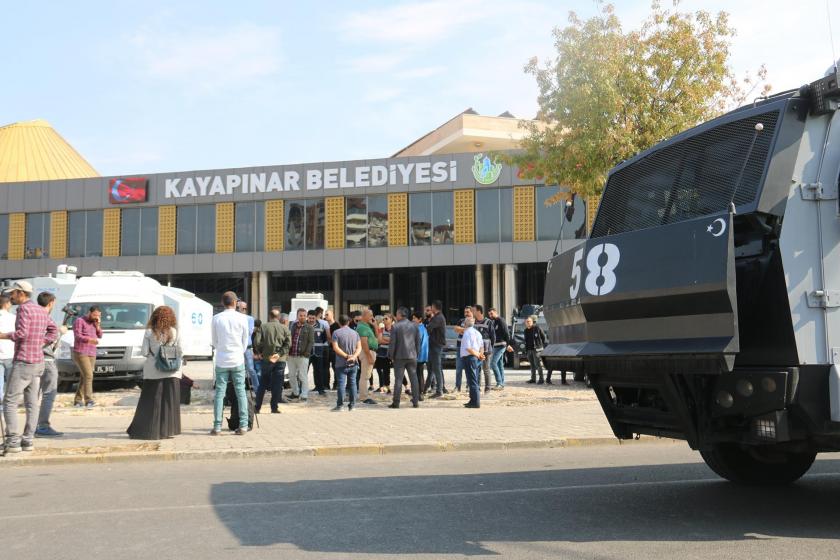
[126,305,181,440]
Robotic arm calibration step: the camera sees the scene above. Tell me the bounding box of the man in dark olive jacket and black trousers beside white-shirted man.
[254,309,292,413]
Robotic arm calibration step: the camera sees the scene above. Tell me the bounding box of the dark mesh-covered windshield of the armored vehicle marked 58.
[592,110,779,237]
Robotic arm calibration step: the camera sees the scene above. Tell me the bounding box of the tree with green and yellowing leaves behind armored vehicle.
[509,0,769,204]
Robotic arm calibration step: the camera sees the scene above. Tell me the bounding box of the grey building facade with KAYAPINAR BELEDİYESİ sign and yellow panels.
[0,115,587,317]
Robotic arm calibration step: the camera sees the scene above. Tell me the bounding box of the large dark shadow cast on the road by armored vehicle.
[210,460,840,555]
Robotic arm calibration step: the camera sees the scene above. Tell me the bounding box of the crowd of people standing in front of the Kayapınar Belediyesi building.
[0,281,566,454]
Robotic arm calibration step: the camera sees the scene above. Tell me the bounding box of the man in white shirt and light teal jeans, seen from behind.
[210,292,251,436]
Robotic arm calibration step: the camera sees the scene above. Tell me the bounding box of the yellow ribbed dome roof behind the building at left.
[0,119,99,183]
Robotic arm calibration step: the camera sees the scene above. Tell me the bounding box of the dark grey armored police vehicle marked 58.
[544,69,840,484]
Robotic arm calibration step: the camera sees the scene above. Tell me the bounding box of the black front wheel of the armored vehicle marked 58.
[700,443,817,486]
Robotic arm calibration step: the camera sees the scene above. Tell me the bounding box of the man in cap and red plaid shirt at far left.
[0,280,58,455]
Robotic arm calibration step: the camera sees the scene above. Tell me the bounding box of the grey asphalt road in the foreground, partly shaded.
[0,444,840,560]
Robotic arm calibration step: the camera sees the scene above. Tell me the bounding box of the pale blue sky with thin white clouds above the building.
[0,0,840,175]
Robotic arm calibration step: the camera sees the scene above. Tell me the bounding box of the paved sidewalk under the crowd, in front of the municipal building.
[0,374,652,466]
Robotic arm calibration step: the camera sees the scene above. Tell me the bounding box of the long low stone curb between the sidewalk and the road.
[0,436,678,468]
